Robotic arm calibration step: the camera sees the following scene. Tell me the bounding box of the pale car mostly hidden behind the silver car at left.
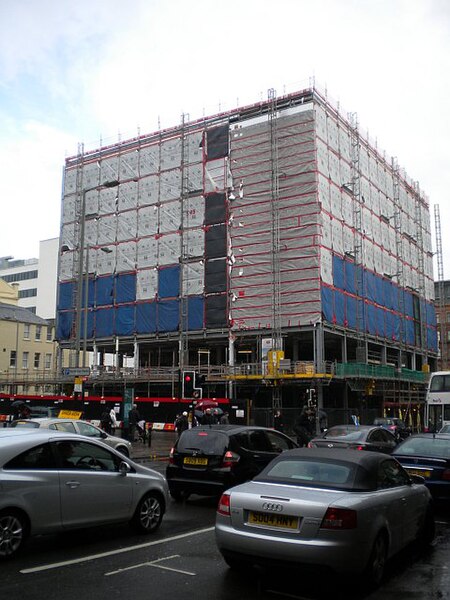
[11,417,132,456]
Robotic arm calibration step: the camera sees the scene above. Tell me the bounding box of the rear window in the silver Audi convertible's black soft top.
[255,458,368,490]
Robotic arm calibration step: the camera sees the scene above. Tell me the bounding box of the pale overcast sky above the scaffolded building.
[0,0,450,278]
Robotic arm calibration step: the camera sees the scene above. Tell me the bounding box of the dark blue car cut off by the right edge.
[392,433,450,502]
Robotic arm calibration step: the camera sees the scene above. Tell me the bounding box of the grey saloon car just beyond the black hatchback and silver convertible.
[309,425,397,454]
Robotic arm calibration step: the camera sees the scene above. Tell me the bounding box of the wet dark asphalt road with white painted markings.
[0,450,450,600]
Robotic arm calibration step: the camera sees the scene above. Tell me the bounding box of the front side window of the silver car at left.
[52,440,121,472]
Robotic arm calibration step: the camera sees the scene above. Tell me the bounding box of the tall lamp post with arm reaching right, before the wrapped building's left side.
[75,180,119,367]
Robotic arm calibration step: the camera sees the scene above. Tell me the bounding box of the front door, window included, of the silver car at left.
[52,439,133,527]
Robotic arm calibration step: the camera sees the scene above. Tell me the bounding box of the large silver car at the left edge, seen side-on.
[0,428,169,559]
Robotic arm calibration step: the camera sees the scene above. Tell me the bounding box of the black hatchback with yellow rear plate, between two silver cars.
[166,425,297,500]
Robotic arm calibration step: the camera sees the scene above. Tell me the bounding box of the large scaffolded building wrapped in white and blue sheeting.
[57,87,437,422]
